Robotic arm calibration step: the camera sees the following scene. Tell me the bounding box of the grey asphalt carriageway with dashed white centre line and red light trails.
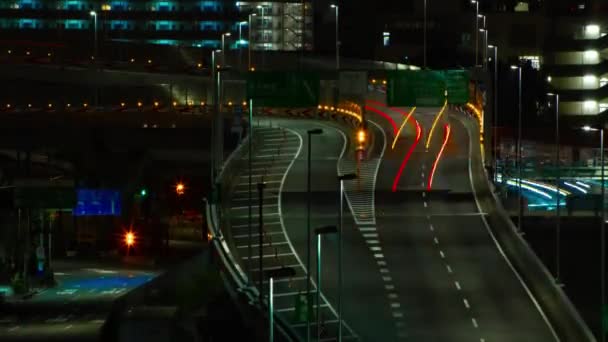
[370,100,557,342]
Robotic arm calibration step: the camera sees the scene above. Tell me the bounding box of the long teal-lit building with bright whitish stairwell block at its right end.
[0,0,312,65]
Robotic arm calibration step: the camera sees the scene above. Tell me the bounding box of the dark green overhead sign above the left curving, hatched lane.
[247,71,319,108]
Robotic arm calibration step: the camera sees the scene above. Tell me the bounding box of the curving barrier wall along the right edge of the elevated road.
[462,113,596,342]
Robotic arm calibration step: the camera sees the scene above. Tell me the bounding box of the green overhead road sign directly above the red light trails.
[386,70,469,107]
